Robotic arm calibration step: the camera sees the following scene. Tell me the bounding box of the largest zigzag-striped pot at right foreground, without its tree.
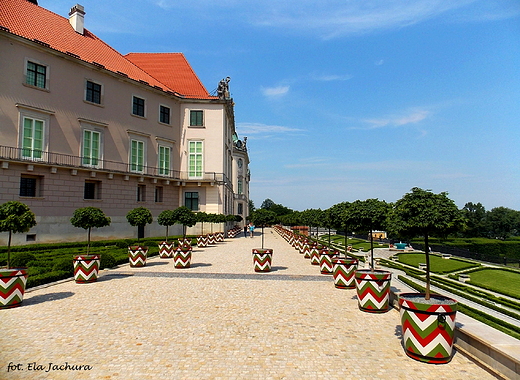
[399,293,457,364]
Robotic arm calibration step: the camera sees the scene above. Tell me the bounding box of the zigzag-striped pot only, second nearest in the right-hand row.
[355,269,392,313]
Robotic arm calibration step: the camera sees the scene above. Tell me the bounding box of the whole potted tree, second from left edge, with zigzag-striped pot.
[70,207,111,284]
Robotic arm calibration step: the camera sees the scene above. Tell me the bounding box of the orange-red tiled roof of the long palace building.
[0,0,214,99]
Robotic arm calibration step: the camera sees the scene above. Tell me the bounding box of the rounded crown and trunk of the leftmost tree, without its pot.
[0,201,36,269]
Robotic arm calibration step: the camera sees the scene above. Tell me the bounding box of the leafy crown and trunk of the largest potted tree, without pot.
[388,187,465,299]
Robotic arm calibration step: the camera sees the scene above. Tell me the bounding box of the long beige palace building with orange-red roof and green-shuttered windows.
[0,0,250,244]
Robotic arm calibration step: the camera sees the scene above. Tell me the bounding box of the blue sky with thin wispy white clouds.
[39,0,520,210]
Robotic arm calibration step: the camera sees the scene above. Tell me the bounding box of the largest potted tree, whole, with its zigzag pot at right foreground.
[388,187,464,364]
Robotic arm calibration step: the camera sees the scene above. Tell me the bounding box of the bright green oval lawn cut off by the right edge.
[469,269,520,299]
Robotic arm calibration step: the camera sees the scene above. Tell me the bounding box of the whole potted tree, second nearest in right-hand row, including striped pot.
[349,199,392,313]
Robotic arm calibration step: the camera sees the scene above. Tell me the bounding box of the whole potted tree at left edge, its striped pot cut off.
[0,201,36,309]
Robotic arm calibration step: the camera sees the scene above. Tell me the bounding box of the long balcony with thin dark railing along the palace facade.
[0,145,229,183]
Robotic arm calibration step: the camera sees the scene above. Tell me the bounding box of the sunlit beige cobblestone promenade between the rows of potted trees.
[0,229,500,380]
